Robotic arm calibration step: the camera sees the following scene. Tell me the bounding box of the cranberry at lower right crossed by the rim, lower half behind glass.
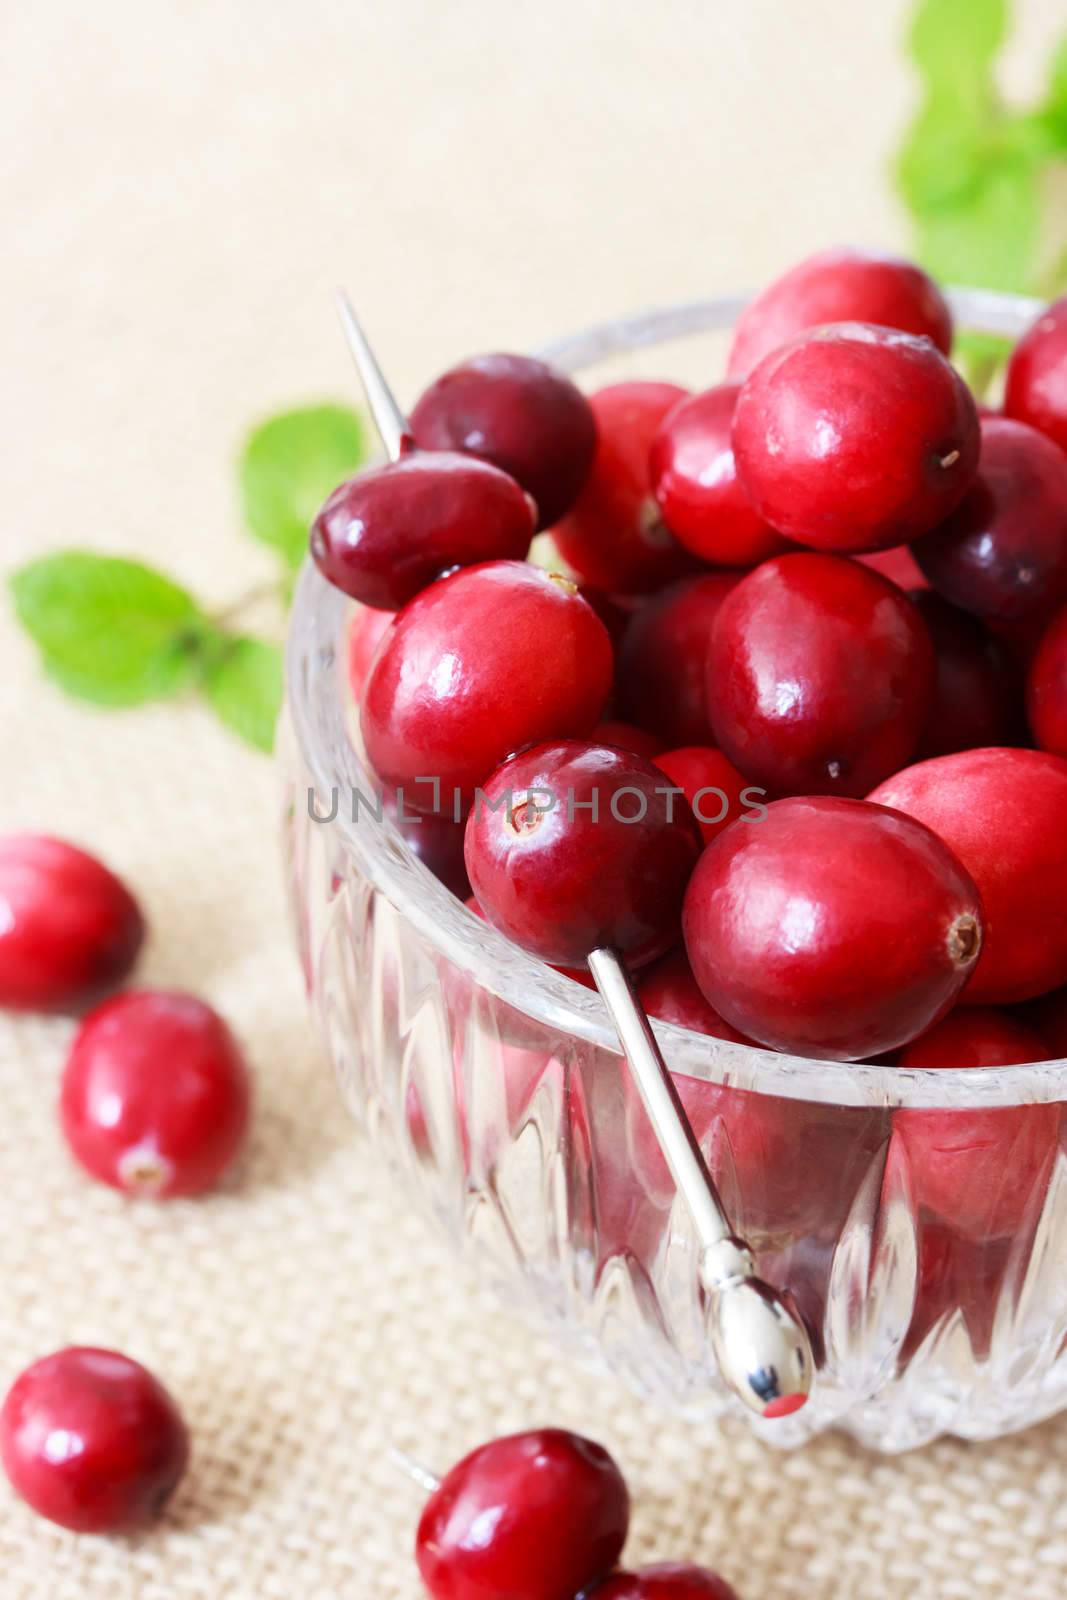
[893,1006,1059,1238]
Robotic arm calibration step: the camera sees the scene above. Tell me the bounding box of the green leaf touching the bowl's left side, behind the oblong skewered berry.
[238,405,366,570]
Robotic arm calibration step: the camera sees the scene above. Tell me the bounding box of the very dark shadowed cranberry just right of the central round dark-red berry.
[912,589,1022,757]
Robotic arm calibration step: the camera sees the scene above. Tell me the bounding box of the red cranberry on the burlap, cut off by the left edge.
[0,834,144,1011]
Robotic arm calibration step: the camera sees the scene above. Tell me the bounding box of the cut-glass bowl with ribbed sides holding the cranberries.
[283,291,1067,1450]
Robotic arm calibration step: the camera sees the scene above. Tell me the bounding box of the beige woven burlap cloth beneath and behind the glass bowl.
[0,0,1067,1600]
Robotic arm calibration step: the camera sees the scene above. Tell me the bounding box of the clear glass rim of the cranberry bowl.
[286,290,1067,1110]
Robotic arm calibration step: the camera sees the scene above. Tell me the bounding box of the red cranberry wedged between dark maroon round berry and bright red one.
[552,382,696,594]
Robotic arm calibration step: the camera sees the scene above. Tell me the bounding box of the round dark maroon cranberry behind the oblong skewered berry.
[411,355,597,528]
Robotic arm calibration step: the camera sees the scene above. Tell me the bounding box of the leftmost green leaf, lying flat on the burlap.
[10,550,206,706]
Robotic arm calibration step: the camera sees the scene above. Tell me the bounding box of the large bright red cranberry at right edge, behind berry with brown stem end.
[870,749,1067,1005]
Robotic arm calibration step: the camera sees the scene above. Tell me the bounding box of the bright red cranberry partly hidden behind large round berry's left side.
[649,384,785,566]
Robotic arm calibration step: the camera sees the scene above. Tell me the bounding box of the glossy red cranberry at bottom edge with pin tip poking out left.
[416,1427,630,1600]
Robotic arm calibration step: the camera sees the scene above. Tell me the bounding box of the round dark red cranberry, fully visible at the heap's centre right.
[707,550,934,795]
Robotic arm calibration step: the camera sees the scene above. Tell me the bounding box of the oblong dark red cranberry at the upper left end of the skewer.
[310,450,534,611]
